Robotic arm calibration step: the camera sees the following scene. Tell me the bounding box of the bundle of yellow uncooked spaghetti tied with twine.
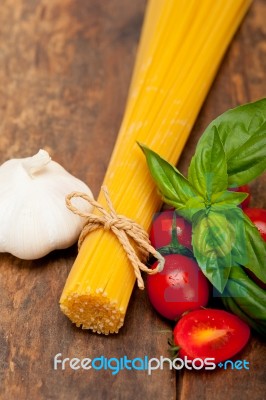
[60,0,251,334]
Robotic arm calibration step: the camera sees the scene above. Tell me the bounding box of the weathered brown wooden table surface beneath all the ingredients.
[0,0,266,400]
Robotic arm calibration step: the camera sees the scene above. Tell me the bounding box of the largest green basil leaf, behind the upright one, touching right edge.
[202,99,266,187]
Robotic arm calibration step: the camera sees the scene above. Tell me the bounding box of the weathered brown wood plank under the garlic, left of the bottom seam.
[0,0,175,400]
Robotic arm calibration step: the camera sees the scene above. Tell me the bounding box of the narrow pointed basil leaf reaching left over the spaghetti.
[139,144,198,210]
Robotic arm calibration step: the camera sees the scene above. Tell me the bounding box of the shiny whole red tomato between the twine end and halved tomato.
[147,254,210,320]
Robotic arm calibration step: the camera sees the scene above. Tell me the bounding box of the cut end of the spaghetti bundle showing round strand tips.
[60,289,125,335]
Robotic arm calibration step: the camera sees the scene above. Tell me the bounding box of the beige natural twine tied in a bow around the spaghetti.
[66,186,165,289]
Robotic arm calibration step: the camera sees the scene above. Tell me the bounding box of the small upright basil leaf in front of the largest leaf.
[188,126,228,199]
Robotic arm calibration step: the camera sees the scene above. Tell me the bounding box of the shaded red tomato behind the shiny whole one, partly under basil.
[150,210,192,250]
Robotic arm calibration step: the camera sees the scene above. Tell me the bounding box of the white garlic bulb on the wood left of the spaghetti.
[0,150,92,260]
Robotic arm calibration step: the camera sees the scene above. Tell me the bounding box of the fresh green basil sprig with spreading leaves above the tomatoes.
[140,99,266,293]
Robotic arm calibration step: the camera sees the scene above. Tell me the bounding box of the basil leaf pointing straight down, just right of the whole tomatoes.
[192,210,232,292]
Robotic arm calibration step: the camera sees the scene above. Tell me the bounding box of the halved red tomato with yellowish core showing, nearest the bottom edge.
[174,309,250,363]
